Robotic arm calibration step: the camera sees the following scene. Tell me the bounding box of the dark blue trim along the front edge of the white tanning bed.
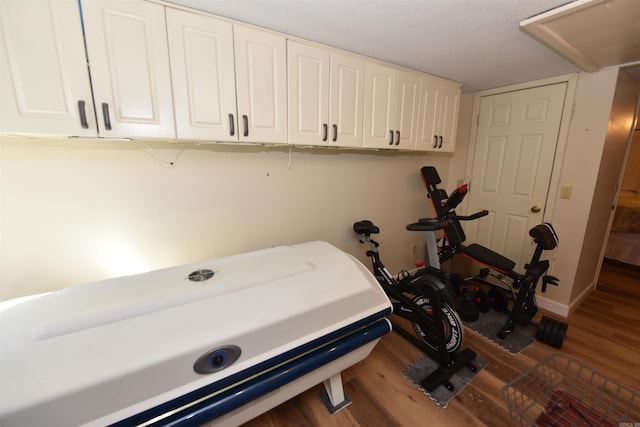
[112,308,391,427]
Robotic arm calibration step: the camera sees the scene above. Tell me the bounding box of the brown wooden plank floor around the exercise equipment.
[245,262,640,427]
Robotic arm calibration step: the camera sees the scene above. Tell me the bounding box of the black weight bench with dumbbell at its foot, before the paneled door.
[420,166,567,348]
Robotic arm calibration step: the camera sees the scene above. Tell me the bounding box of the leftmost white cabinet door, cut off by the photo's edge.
[0,0,97,136]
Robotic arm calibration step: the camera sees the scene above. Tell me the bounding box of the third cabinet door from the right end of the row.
[394,71,420,150]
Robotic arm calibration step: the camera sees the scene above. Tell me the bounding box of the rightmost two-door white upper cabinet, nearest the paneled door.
[416,76,460,152]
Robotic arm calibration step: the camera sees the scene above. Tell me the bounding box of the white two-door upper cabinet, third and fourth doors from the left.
[166,8,287,143]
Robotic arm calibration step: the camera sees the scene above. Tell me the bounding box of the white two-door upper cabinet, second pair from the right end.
[364,63,420,150]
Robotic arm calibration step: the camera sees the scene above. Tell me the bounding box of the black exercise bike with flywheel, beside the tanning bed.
[353,220,477,392]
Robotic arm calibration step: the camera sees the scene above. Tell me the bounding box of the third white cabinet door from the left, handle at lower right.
[166,8,238,141]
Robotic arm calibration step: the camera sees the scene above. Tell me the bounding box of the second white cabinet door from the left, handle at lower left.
[82,0,175,138]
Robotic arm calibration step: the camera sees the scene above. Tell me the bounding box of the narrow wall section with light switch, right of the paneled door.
[549,68,635,309]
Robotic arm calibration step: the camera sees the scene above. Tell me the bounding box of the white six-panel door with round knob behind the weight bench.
[468,83,566,268]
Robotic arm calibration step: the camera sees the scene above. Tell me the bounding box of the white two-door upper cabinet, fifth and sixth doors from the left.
[287,41,364,147]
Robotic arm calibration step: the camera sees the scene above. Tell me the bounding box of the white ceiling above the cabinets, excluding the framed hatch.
[170,0,640,93]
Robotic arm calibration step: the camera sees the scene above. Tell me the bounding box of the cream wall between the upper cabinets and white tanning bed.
[0,138,451,300]
